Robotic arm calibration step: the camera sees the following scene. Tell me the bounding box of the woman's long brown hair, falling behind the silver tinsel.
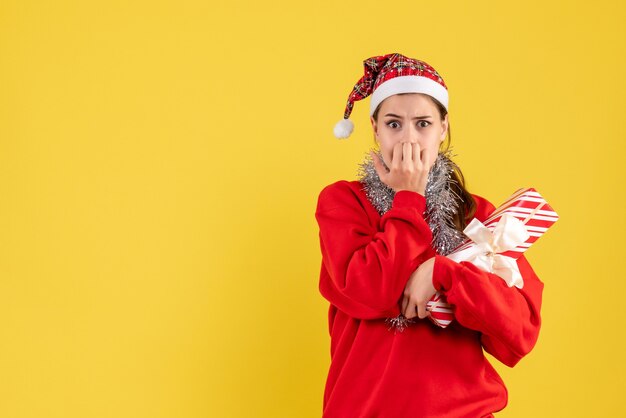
[372,93,476,232]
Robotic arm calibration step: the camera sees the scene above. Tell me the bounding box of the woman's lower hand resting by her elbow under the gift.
[401,257,437,319]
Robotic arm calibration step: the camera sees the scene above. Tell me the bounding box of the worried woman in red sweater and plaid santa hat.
[315,54,543,418]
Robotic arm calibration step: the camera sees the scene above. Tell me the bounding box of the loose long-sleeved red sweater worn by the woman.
[315,181,543,418]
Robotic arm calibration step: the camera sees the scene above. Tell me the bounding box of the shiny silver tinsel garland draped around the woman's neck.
[359,150,465,331]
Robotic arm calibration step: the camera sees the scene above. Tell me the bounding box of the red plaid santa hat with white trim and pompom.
[333,53,448,139]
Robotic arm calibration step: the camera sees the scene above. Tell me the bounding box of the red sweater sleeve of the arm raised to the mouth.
[315,181,432,319]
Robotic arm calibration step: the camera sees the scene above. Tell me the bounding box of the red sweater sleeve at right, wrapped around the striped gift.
[433,195,544,367]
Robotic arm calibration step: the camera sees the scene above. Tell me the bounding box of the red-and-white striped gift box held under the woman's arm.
[427,188,559,328]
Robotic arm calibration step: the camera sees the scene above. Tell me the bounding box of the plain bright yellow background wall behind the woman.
[0,0,626,418]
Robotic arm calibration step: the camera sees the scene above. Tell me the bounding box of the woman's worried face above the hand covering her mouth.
[370,93,448,167]
